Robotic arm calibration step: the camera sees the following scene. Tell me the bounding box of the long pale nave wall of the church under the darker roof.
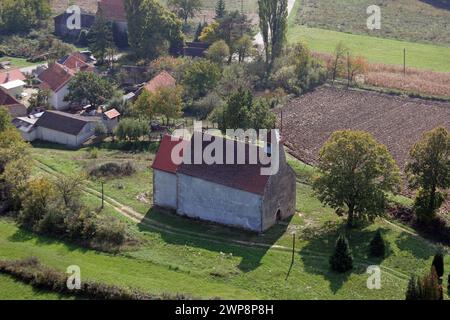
[178,174,262,232]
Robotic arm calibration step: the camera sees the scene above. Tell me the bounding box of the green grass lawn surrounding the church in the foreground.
[0,146,450,299]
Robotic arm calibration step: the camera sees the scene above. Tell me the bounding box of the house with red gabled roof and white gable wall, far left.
[38,62,77,110]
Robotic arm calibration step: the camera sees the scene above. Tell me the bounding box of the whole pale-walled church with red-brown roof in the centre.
[152,132,296,232]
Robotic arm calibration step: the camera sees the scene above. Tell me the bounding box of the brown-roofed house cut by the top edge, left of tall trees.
[97,0,128,48]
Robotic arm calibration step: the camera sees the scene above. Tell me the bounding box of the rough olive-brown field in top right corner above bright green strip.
[297,0,450,46]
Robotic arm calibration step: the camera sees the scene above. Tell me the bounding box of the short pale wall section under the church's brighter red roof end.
[153,170,178,209]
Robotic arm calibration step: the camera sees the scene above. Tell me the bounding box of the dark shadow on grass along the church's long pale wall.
[138,208,291,272]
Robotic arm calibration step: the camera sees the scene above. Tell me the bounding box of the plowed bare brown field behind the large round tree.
[282,86,450,168]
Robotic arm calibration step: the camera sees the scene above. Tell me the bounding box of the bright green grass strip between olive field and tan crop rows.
[288,0,450,72]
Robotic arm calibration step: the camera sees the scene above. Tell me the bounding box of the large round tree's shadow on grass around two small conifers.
[299,222,391,294]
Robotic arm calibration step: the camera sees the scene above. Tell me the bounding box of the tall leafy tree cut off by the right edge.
[406,127,450,221]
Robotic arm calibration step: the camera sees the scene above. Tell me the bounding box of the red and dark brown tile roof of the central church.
[153,133,270,195]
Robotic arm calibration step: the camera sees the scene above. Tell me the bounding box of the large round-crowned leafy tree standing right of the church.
[313,130,400,227]
